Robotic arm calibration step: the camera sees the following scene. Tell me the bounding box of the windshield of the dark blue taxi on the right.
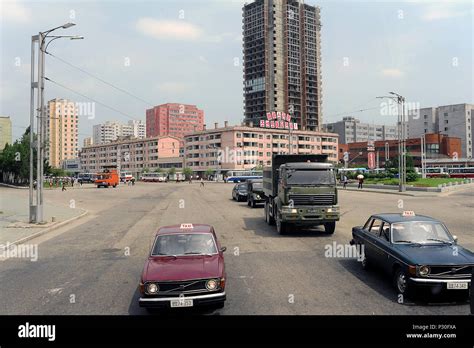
[392,221,453,244]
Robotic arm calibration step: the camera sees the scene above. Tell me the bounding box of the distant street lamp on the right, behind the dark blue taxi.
[377,92,406,192]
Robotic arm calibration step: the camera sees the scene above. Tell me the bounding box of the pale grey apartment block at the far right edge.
[407,104,474,158]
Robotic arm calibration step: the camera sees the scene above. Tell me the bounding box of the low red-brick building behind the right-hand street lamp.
[338,133,462,167]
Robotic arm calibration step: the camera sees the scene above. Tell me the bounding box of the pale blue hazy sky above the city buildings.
[0,0,474,146]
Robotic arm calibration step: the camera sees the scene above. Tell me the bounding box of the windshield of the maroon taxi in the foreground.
[152,233,217,256]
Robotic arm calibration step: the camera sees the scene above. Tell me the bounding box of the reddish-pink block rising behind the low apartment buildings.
[146,103,204,140]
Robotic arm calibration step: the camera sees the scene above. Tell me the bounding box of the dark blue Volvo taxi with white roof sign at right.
[351,212,474,295]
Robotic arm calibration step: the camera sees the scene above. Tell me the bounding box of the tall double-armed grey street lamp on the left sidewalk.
[29,23,83,223]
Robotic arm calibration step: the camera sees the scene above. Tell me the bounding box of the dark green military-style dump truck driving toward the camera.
[263,155,340,234]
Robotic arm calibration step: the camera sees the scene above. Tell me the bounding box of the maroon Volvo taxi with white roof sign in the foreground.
[139,224,226,309]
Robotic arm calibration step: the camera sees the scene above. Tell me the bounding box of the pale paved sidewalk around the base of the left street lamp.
[0,187,87,245]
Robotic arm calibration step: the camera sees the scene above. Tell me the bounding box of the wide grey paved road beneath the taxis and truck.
[0,183,474,315]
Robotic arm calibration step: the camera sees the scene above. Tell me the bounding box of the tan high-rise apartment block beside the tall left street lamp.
[46,99,79,168]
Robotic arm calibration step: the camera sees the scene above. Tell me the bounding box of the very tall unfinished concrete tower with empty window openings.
[243,0,322,131]
